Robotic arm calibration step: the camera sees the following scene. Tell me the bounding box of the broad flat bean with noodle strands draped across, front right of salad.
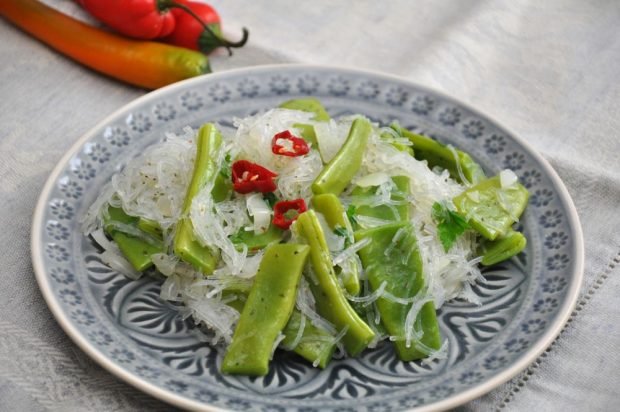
[355,222,441,361]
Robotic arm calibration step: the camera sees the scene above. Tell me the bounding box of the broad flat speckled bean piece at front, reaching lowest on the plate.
[222,243,310,376]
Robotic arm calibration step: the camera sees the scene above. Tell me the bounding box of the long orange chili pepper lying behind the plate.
[0,0,211,89]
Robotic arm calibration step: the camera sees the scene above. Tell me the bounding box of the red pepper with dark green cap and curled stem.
[164,1,248,54]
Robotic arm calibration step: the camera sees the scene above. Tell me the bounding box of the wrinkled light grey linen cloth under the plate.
[0,0,620,412]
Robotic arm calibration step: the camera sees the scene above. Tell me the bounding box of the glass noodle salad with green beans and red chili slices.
[83,98,529,376]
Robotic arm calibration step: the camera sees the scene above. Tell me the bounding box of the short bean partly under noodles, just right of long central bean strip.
[312,193,360,295]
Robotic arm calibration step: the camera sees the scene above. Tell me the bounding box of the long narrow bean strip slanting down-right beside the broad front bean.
[294,210,375,356]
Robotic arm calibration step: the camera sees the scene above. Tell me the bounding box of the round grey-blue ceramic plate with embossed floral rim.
[32,65,583,412]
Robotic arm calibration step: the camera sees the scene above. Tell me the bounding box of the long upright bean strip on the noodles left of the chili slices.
[173,123,222,274]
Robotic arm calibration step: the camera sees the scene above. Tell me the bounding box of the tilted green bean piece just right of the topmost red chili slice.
[312,118,372,195]
